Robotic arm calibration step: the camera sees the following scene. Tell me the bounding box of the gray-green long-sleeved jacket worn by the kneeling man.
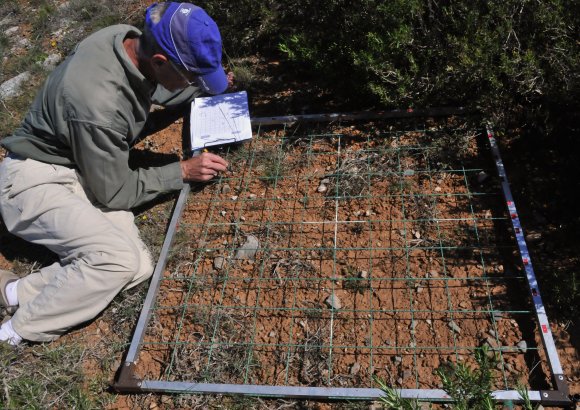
[2,25,201,209]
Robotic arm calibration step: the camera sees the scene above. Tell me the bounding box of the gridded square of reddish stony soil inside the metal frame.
[127,121,549,398]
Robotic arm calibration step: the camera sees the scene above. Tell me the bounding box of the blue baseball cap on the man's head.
[145,2,228,94]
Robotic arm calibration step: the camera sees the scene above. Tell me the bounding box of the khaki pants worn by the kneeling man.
[0,155,153,341]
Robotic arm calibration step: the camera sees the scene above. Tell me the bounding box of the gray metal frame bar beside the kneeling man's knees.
[125,184,191,364]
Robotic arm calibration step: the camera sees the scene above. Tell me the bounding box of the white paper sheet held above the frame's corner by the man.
[190,91,252,151]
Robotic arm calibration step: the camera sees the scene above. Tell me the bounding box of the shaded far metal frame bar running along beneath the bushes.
[251,107,474,125]
